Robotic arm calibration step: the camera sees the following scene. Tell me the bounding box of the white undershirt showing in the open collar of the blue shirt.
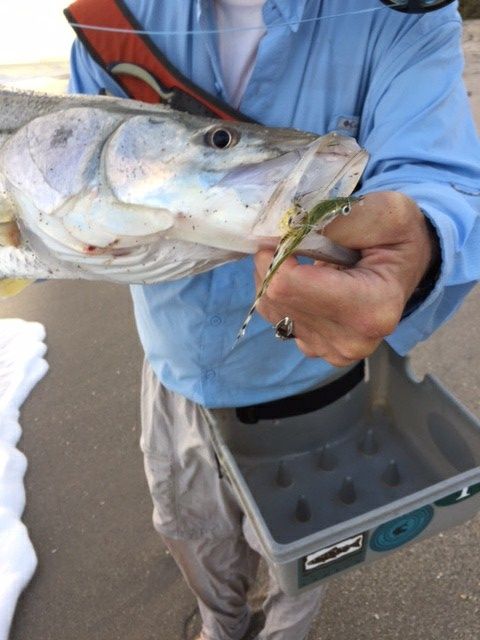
[214,0,266,108]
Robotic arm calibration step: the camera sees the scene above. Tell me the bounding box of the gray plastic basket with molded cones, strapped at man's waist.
[212,343,480,595]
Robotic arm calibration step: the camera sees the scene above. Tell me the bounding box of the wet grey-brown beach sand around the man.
[0,21,480,640]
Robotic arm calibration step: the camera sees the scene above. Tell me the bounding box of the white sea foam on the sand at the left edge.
[0,318,48,640]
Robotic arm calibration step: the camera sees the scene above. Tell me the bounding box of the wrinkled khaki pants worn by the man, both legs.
[140,364,323,640]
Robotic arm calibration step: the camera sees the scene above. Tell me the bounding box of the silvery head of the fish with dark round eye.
[104,110,367,252]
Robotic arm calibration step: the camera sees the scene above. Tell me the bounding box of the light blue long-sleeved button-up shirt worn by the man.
[70,0,480,407]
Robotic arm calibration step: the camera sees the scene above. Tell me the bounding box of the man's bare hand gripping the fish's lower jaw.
[255,191,436,367]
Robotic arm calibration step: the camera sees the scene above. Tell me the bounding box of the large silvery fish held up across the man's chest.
[0,87,368,296]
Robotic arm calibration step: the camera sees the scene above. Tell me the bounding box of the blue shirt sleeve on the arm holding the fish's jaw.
[360,12,480,354]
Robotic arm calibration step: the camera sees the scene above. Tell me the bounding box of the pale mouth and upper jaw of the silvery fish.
[218,132,368,237]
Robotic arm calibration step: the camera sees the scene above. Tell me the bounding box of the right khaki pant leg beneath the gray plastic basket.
[243,518,325,640]
